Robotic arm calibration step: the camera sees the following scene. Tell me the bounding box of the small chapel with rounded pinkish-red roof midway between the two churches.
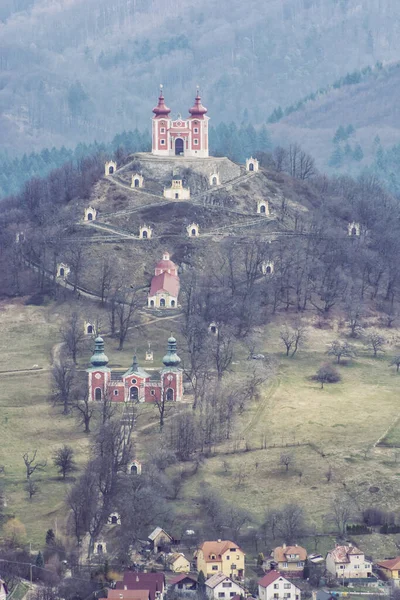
[147,252,180,308]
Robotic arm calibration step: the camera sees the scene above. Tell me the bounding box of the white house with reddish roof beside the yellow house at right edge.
[326,545,372,581]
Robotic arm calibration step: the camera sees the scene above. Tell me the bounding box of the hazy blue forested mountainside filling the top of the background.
[0,0,400,151]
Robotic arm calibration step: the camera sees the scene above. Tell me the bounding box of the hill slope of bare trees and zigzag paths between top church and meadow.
[0,147,400,332]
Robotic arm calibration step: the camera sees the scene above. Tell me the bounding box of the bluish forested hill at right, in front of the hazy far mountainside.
[268,63,400,177]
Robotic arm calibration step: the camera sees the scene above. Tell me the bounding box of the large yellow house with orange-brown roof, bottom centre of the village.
[195,540,245,580]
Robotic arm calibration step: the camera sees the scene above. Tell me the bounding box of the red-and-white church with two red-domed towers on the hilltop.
[152,86,210,158]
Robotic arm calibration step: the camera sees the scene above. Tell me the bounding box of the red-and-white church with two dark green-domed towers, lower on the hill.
[86,336,183,402]
